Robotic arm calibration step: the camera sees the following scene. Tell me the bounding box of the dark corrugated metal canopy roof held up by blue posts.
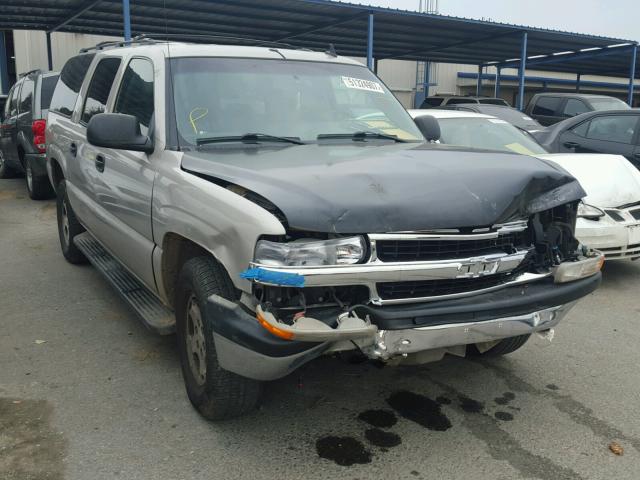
[0,0,640,78]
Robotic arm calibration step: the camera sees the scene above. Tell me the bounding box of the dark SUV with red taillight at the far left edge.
[0,70,59,200]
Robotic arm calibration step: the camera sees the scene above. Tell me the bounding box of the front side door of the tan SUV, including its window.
[95,57,155,290]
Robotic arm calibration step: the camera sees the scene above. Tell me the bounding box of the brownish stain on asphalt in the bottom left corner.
[0,398,66,480]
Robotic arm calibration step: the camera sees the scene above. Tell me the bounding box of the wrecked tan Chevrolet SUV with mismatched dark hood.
[47,43,603,419]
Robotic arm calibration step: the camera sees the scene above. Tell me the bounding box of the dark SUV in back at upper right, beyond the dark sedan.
[525,93,630,126]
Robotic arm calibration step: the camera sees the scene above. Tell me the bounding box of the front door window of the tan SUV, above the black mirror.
[113,58,153,135]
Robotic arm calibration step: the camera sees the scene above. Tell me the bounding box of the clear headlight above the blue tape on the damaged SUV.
[255,237,366,267]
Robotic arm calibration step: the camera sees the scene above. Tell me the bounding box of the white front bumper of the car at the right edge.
[576,218,640,260]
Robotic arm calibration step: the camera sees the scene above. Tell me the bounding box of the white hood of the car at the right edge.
[538,153,640,207]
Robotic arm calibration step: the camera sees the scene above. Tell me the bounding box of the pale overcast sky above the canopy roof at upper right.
[358,0,640,41]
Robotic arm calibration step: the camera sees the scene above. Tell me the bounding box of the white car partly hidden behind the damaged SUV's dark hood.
[409,109,640,260]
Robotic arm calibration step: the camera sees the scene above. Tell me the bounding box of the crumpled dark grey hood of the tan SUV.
[182,143,585,233]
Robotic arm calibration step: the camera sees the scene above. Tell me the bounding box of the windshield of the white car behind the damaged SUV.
[438,118,547,155]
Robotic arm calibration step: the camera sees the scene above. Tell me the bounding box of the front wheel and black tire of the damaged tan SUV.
[175,257,262,420]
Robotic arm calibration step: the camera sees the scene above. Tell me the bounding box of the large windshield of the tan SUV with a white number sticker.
[171,58,424,145]
